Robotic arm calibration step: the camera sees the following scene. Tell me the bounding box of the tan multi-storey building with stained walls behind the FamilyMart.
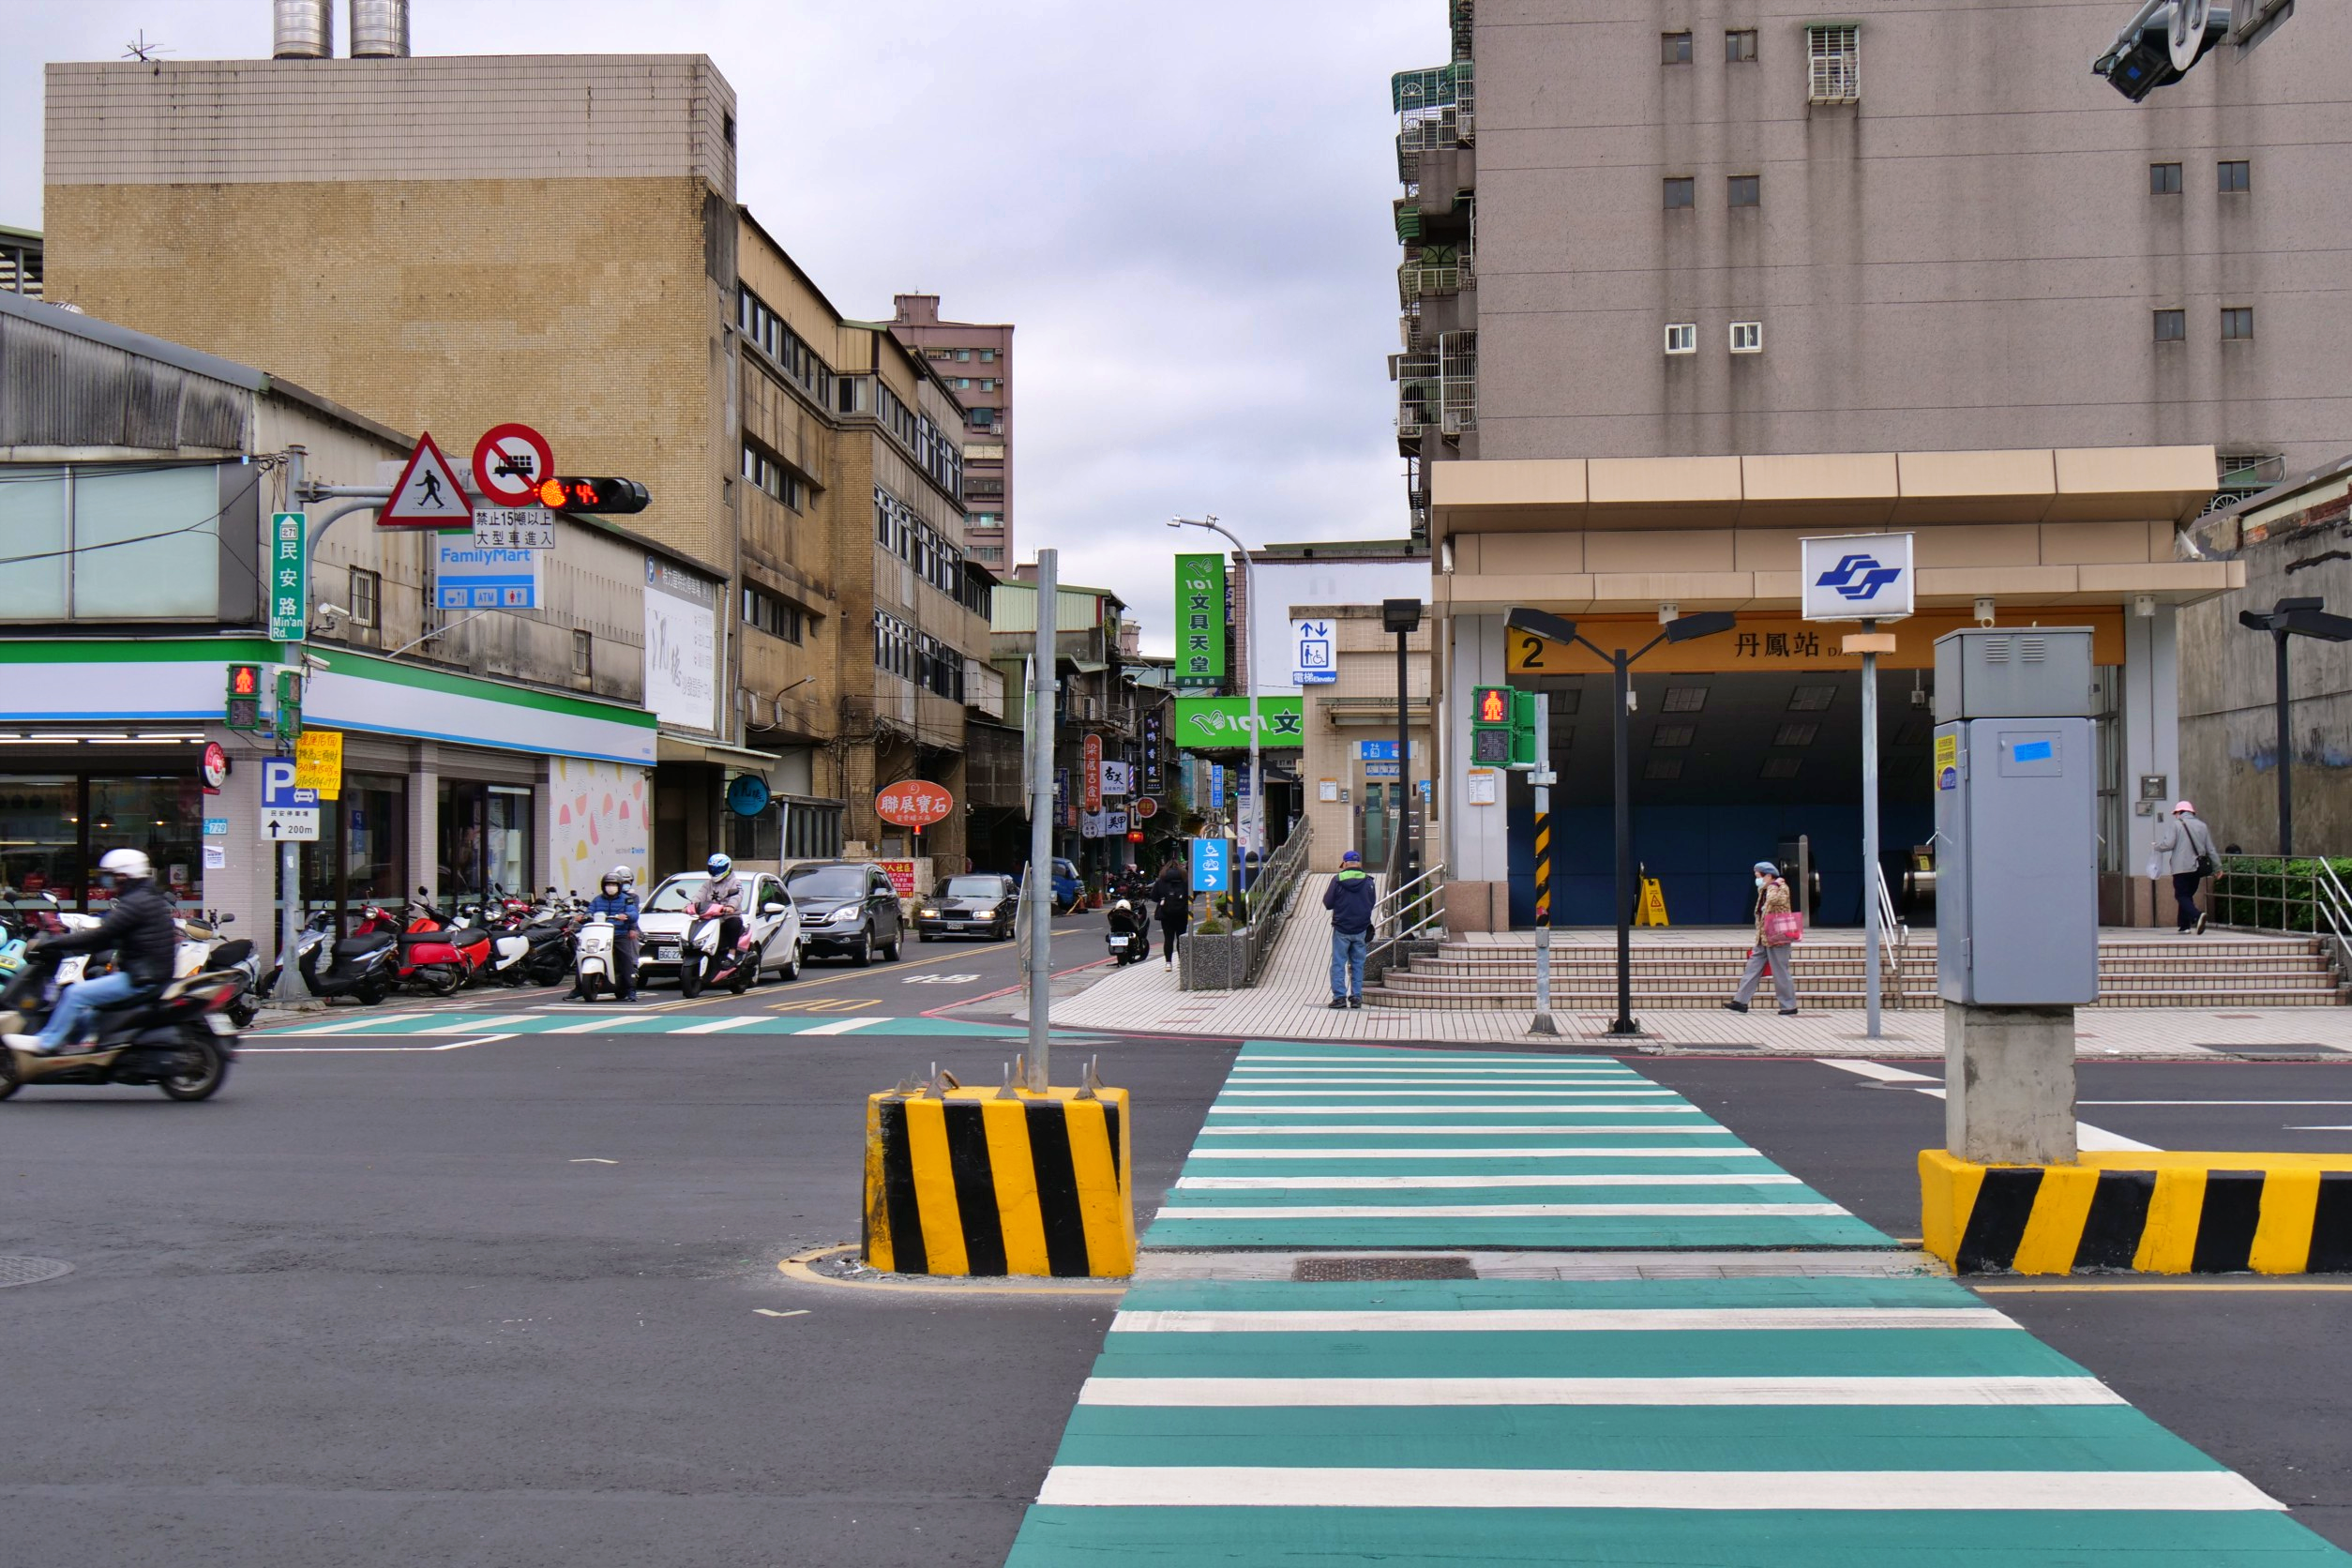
[42,34,988,869]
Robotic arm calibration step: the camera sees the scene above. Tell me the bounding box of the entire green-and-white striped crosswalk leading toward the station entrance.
[1009,1047,2347,1568]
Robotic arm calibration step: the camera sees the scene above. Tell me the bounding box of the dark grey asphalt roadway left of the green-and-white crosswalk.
[0,917,1232,1568]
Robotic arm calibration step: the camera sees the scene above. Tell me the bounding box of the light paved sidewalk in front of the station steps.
[1034,880,2352,1058]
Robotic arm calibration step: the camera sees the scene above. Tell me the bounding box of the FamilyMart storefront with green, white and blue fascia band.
[0,637,656,952]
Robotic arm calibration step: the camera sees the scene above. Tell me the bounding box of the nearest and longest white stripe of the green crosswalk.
[1037,1465,2286,1514]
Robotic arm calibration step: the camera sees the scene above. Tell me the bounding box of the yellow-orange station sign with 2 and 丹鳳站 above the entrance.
[1503,604,2124,674]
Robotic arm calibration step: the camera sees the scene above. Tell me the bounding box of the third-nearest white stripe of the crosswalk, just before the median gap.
[1110,1307,2025,1333]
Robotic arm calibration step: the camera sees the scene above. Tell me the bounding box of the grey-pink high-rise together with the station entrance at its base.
[1390,0,2352,919]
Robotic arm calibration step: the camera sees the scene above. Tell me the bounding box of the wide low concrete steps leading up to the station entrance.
[1364,931,2347,1013]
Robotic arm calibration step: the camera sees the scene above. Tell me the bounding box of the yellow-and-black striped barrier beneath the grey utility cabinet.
[1920,1150,2352,1274]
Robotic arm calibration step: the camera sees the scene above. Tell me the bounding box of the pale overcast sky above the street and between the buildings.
[0,0,1446,651]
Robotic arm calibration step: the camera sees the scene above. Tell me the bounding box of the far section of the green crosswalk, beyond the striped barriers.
[1143,1044,1893,1248]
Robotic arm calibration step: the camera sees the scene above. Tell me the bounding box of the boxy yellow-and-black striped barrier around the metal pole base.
[861,1086,1136,1279]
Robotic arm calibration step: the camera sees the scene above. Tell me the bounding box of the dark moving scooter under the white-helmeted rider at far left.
[0,942,251,1100]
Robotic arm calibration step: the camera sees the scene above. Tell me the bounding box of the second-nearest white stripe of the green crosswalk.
[1078,1375,2129,1410]
